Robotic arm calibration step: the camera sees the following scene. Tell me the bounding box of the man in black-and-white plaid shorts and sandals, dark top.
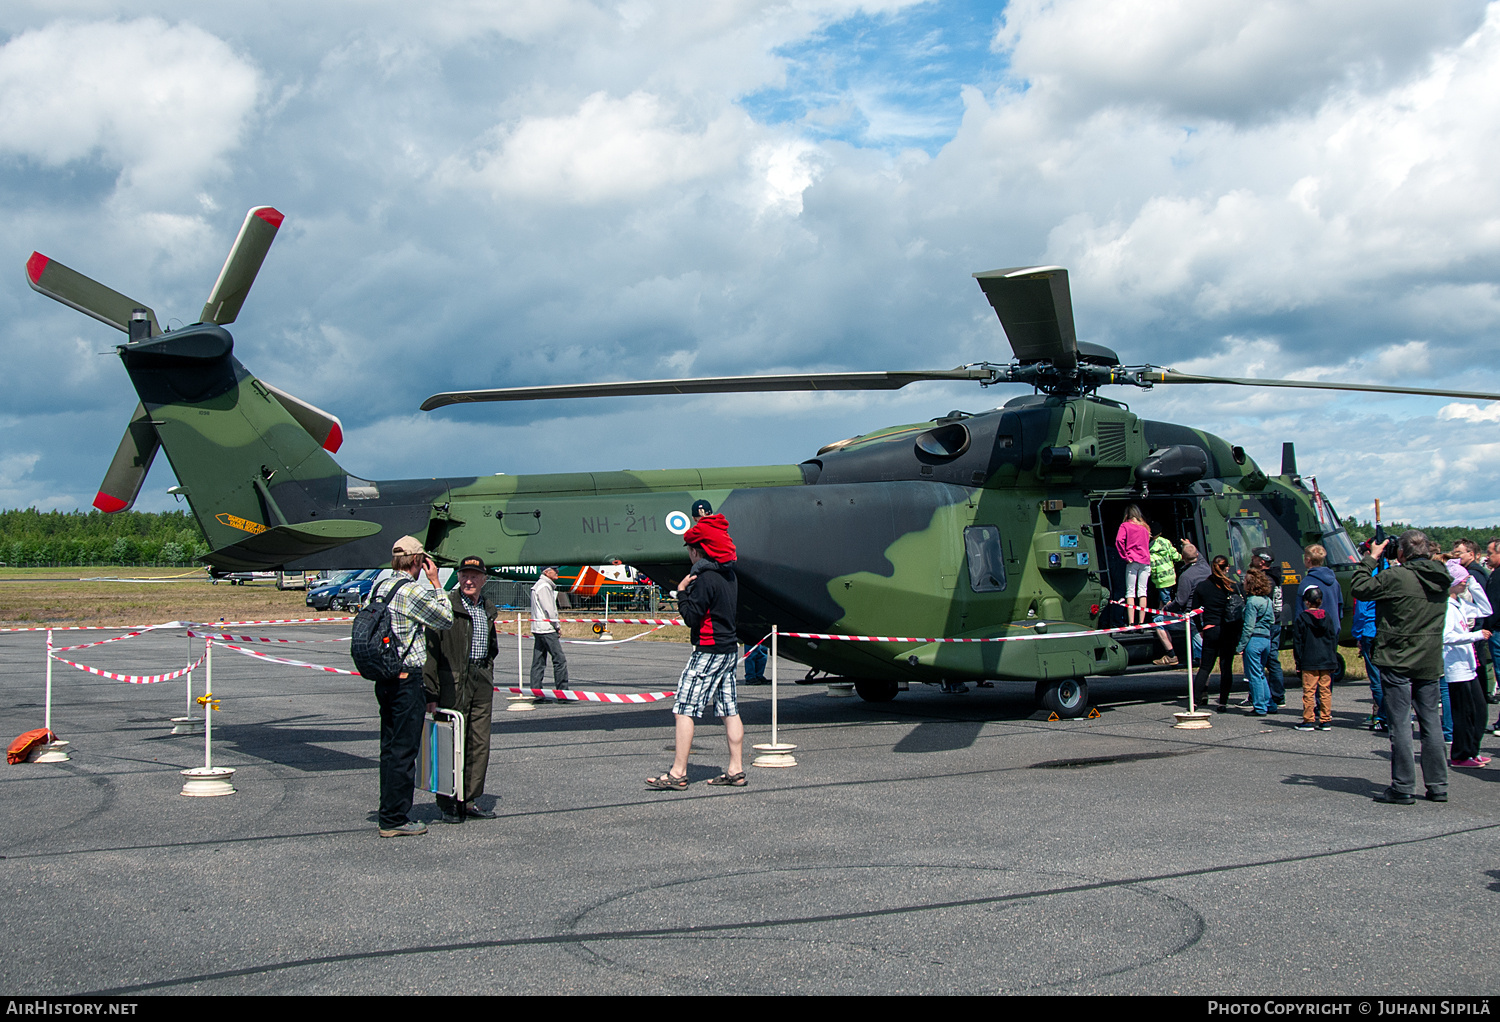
[647,524,746,791]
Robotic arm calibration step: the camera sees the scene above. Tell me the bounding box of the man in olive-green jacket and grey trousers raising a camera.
[1353,528,1451,806]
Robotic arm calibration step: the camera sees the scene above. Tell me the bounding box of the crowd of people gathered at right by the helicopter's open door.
[1116,506,1500,804]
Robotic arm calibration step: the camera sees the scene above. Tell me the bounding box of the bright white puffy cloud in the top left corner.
[0,18,261,201]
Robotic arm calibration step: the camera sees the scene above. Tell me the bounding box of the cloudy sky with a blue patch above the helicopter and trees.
[0,0,1500,525]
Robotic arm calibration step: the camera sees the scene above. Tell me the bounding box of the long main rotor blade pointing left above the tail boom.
[422,366,995,411]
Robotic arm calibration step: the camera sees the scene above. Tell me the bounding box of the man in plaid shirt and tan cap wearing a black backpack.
[371,536,453,837]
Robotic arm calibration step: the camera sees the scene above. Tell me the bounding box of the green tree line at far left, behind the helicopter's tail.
[0,507,209,567]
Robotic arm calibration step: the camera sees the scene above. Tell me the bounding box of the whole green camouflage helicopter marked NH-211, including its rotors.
[27,206,1500,717]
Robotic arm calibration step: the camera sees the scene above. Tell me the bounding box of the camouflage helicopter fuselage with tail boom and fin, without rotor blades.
[120,326,1350,696]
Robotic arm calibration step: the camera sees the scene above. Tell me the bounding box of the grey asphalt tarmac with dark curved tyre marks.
[0,626,1500,995]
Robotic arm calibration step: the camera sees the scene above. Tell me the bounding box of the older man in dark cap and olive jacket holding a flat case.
[422,557,500,824]
